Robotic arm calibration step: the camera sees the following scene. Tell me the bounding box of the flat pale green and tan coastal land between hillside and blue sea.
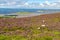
[0,12,60,18]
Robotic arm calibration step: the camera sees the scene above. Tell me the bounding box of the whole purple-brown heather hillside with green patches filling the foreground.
[0,13,60,40]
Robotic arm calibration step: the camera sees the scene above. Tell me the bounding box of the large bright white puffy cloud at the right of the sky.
[40,1,60,8]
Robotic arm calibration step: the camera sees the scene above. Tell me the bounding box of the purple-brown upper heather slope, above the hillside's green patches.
[0,13,60,29]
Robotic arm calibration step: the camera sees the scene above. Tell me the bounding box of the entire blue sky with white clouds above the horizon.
[0,0,60,9]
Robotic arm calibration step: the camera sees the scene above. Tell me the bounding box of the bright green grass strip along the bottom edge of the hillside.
[0,35,53,40]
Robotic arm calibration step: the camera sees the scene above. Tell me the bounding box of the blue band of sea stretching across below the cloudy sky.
[0,8,60,14]
